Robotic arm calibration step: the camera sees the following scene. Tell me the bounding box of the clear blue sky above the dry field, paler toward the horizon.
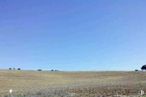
[0,0,146,70]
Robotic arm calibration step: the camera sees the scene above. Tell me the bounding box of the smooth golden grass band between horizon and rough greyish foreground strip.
[0,71,146,96]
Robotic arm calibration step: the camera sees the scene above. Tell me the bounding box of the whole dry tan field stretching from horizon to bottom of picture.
[0,70,146,97]
